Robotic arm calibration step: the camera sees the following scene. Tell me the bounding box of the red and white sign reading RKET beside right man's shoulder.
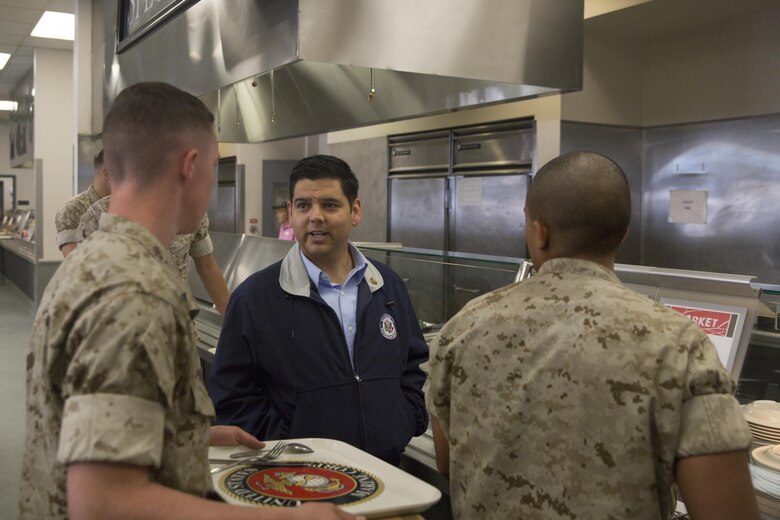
[660,298,747,371]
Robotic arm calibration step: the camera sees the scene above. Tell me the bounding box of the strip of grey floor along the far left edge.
[0,275,33,520]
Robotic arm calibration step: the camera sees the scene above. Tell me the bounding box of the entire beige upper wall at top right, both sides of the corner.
[562,7,780,127]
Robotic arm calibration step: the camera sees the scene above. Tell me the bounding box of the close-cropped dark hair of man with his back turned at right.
[526,151,631,256]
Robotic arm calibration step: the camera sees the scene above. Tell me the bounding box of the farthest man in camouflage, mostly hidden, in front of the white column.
[54,150,111,257]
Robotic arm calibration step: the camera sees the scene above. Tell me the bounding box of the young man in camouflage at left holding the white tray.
[20,83,354,520]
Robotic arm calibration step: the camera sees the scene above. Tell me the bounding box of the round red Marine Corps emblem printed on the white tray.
[219,461,384,507]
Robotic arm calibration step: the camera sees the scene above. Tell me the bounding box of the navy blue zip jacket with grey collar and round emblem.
[209,244,428,465]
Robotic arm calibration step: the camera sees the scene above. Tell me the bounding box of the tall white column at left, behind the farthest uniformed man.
[33,49,75,260]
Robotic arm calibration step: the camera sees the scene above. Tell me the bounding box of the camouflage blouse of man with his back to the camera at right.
[426,258,750,519]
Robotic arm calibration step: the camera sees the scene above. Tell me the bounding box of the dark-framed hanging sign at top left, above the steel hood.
[116,0,198,54]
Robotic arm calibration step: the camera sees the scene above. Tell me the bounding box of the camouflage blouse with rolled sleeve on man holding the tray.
[20,213,214,520]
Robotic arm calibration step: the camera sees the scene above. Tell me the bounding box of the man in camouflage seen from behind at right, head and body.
[426,152,758,519]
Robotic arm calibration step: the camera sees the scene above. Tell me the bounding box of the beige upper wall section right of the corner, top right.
[642,7,780,126]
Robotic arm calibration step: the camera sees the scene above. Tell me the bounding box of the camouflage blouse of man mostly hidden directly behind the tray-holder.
[76,195,214,281]
